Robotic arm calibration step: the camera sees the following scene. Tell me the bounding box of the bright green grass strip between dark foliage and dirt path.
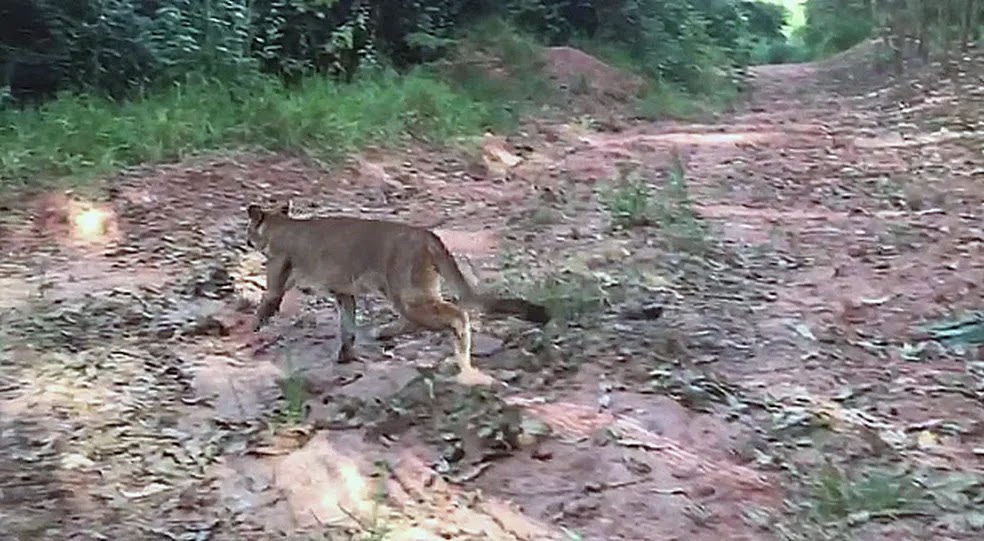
[0,70,515,187]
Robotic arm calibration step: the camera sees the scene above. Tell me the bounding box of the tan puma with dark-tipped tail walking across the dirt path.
[246,201,550,384]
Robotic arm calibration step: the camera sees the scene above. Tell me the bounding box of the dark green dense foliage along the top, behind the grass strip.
[0,0,785,102]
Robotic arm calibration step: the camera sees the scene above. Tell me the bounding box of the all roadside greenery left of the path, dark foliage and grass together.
[0,0,785,188]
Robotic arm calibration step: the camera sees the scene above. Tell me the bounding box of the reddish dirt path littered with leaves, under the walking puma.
[0,54,984,540]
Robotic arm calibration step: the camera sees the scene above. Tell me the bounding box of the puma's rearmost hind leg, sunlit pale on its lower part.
[399,299,496,386]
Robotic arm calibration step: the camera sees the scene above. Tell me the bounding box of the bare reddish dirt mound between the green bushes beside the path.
[543,47,645,102]
